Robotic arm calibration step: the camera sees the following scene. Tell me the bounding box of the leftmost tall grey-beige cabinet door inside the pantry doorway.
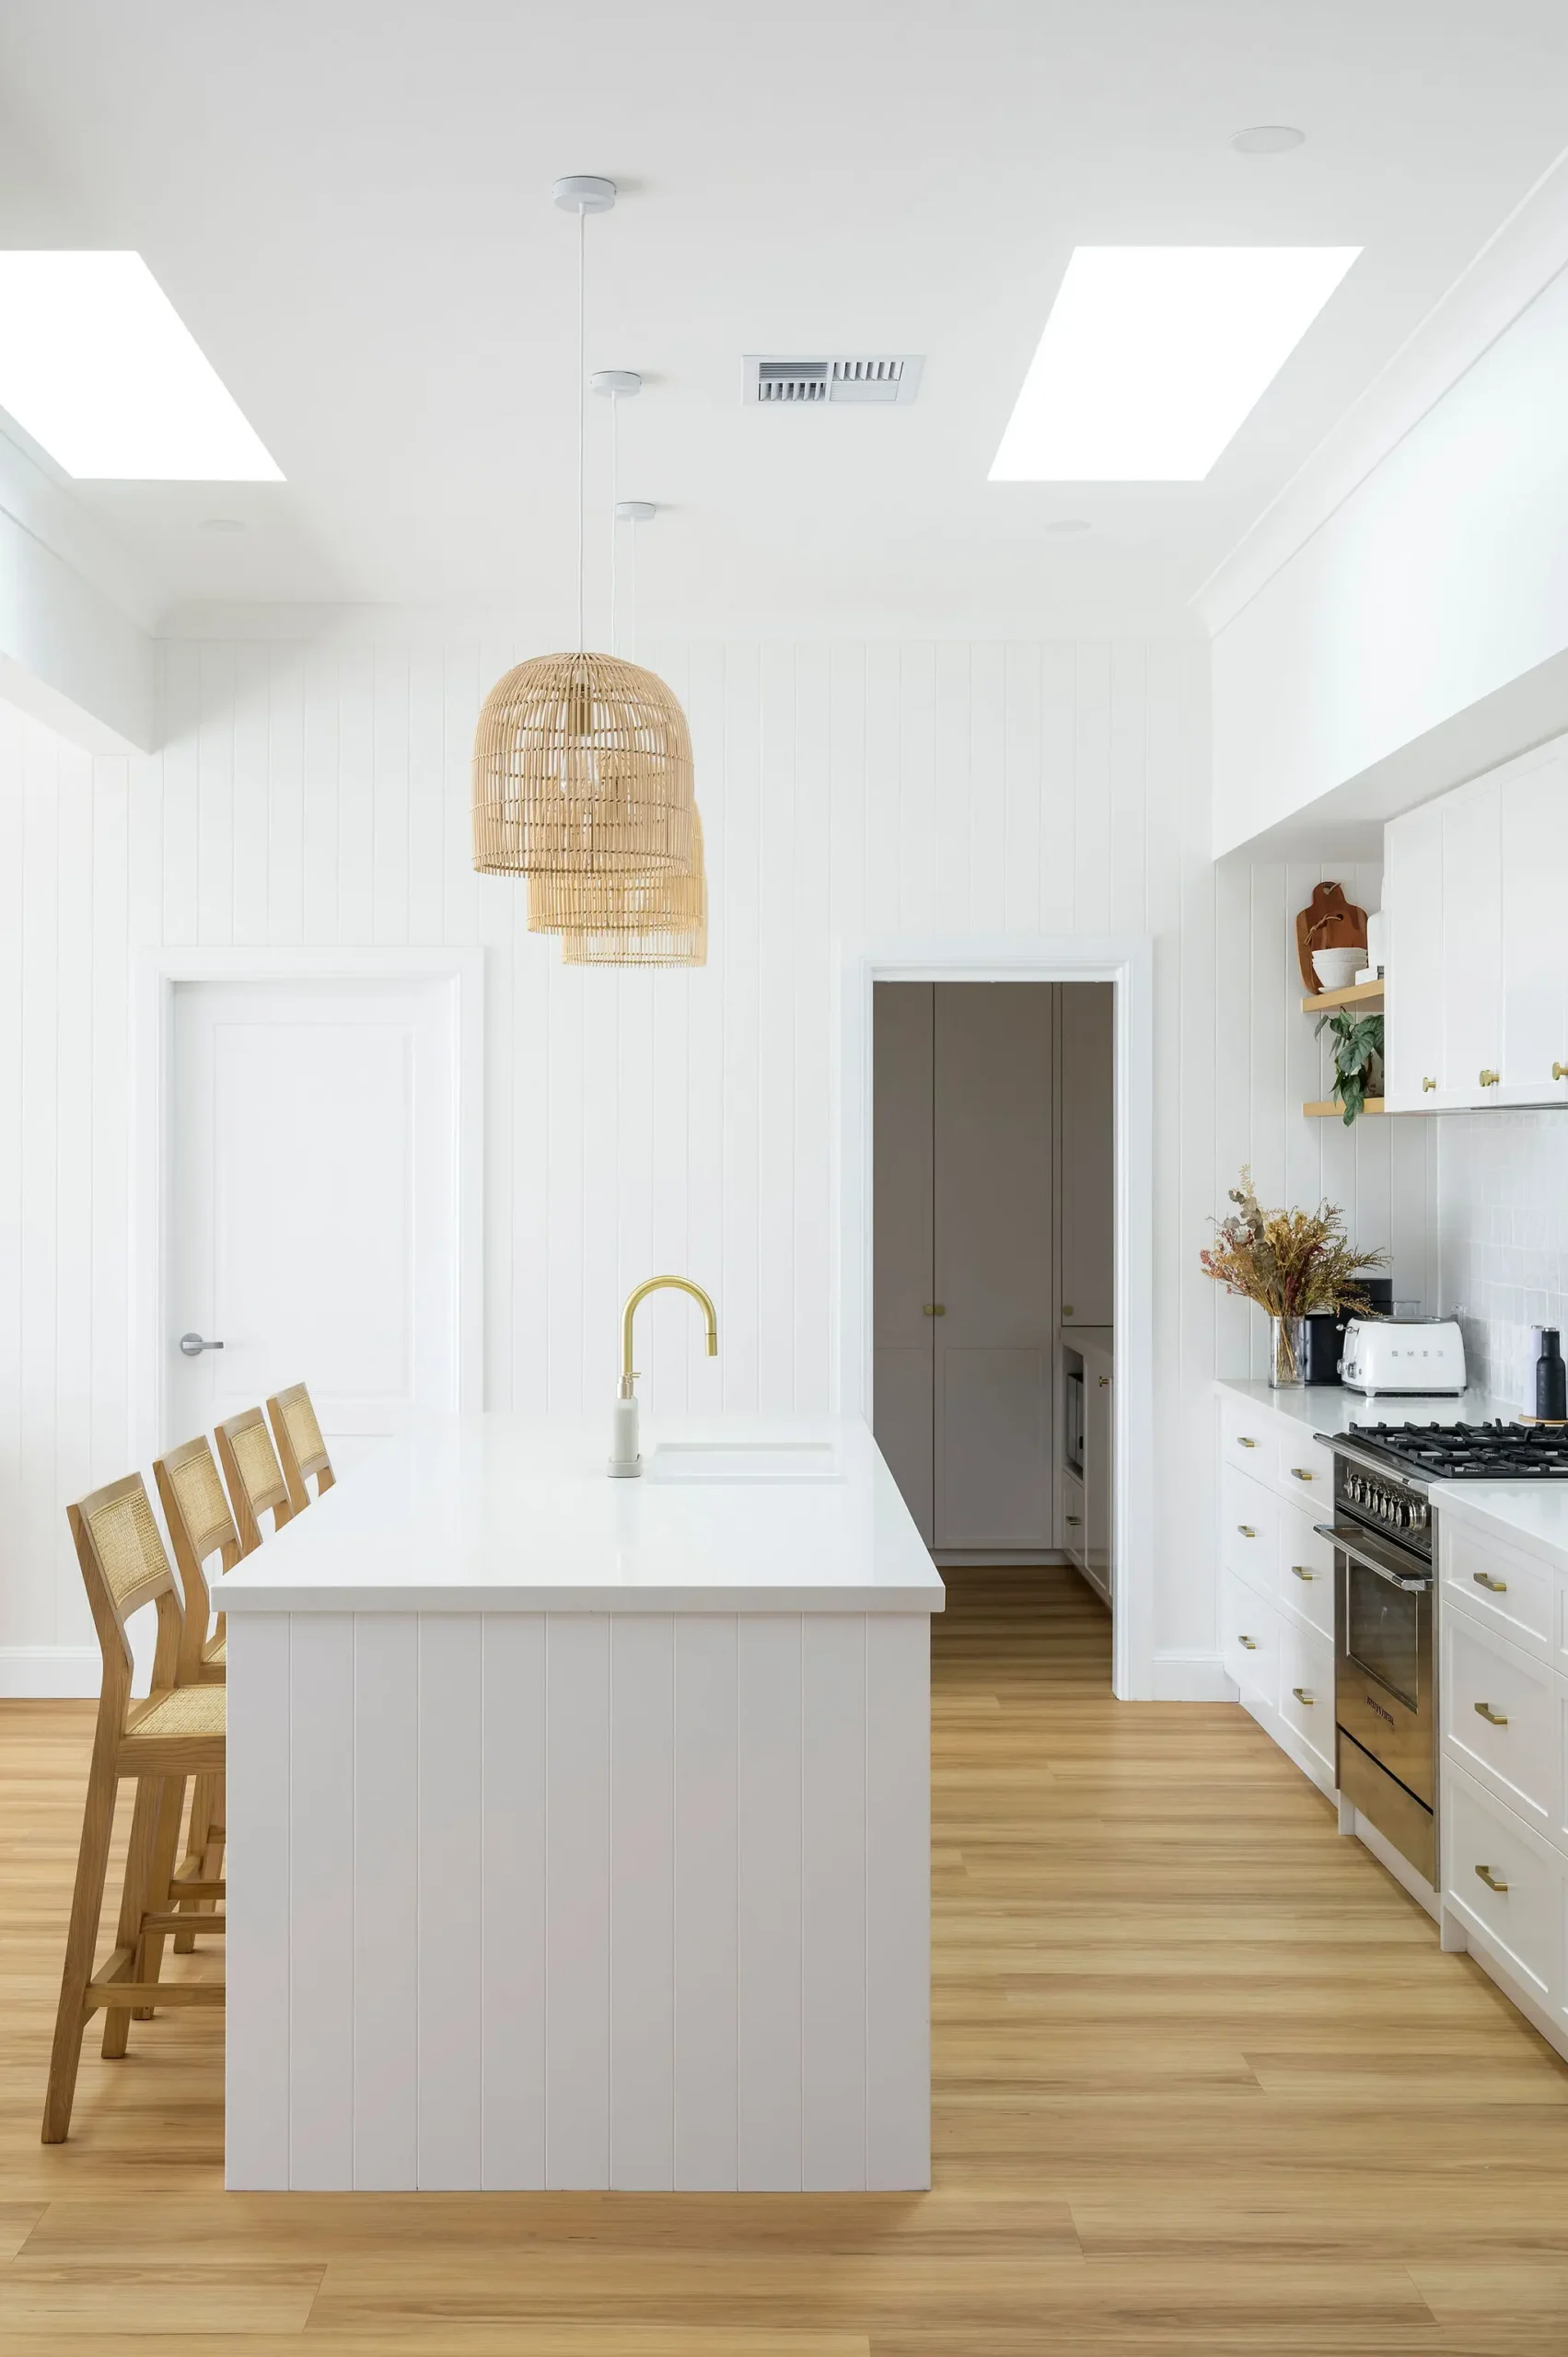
[873,983,938,1546]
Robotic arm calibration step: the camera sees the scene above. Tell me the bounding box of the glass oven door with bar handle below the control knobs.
[1318,1523,1438,1808]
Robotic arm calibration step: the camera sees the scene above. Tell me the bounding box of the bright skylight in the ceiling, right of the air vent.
[991,245,1361,483]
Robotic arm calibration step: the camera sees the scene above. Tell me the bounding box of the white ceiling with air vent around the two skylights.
[0,0,1568,636]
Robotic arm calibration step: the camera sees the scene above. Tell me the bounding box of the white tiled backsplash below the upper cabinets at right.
[1429,1112,1568,1411]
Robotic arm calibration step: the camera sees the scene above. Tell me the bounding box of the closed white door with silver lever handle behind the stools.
[163,981,458,1466]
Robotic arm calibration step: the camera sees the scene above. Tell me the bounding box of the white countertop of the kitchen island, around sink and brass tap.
[215,1405,943,1615]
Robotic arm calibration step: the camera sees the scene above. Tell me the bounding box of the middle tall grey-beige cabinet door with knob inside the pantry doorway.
[934,983,1056,1550]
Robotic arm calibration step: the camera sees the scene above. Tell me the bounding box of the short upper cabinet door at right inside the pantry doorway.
[1056,983,1115,1327]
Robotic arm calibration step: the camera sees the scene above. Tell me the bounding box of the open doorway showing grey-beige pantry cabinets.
[873,981,1118,1608]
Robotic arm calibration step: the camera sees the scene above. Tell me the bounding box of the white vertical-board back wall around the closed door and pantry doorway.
[0,620,1431,1692]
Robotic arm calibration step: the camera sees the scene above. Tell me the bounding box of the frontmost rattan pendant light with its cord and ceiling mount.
[474,174,693,877]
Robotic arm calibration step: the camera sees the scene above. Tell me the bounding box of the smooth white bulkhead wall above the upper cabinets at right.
[1214,271,1568,851]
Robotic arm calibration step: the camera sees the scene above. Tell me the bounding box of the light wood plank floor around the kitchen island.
[0,1573,1568,2357]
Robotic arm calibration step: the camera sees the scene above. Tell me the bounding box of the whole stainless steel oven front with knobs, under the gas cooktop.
[1318,1440,1438,1883]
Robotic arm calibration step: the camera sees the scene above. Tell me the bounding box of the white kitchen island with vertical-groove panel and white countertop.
[219,1417,943,2192]
